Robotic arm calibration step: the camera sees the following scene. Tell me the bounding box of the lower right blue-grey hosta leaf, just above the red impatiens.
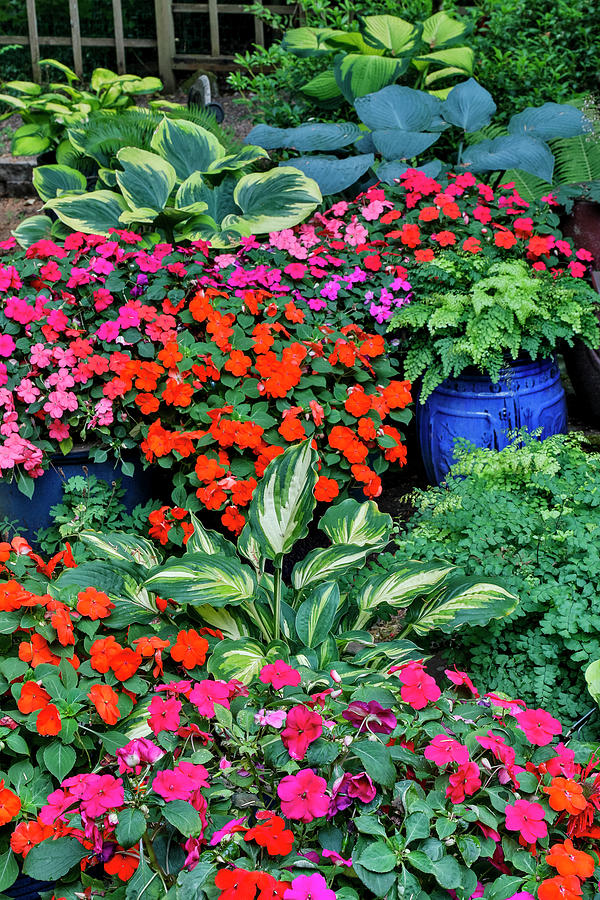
[462,134,554,183]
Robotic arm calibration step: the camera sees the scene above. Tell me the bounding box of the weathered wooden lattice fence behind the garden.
[0,0,294,91]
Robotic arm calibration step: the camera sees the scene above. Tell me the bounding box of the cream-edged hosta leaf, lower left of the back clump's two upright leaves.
[116,147,177,212]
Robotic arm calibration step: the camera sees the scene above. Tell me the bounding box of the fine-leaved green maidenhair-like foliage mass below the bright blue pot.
[366,436,600,721]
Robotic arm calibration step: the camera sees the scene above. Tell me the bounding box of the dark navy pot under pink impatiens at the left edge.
[0,448,166,540]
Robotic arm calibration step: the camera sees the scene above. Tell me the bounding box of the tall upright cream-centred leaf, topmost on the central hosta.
[248,441,318,559]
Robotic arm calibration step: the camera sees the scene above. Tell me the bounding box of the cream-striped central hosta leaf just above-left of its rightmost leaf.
[354,561,456,628]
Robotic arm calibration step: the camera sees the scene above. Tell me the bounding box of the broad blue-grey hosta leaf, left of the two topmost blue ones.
[354,84,442,131]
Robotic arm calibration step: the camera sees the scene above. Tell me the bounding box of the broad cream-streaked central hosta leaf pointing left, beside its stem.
[144,553,256,606]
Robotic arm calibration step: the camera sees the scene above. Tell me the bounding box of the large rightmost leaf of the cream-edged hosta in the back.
[227,166,323,234]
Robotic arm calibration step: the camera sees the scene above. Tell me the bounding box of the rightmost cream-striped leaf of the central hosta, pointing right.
[406,576,519,634]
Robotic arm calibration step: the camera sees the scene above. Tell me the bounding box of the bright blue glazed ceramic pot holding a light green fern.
[416,359,567,484]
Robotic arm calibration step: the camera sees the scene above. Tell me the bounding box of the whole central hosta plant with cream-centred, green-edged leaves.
[58,441,518,682]
